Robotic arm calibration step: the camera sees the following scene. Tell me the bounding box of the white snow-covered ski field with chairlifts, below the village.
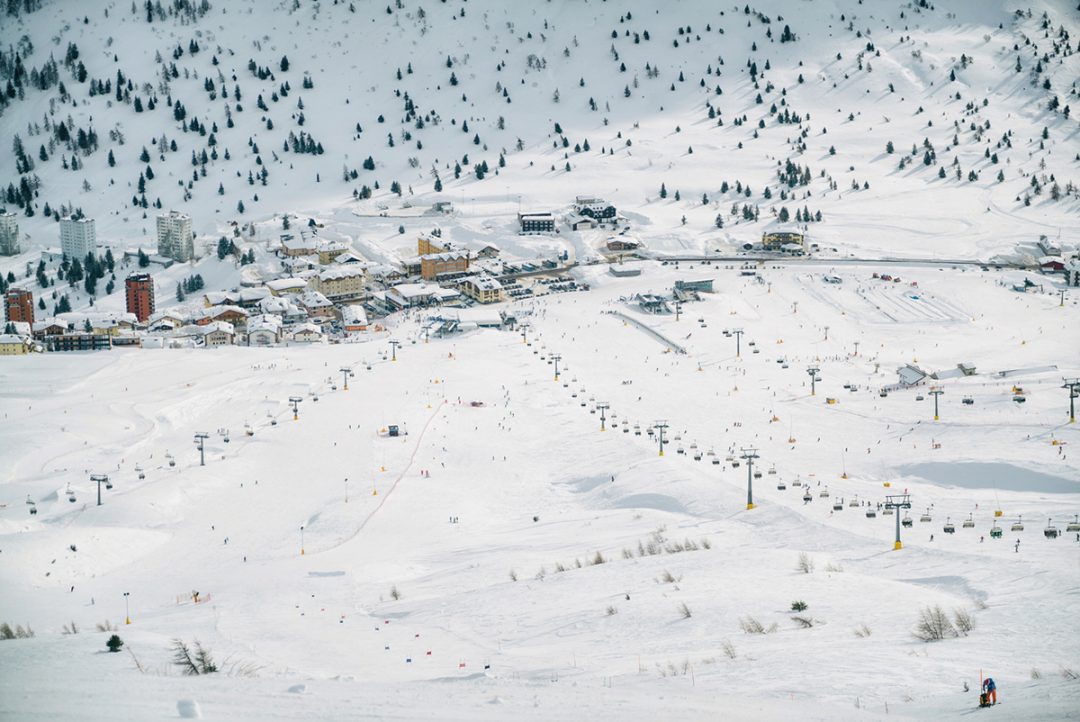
[0,262,1080,720]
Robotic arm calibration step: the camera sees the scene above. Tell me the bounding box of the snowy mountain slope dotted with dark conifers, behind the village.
[0,0,1080,258]
